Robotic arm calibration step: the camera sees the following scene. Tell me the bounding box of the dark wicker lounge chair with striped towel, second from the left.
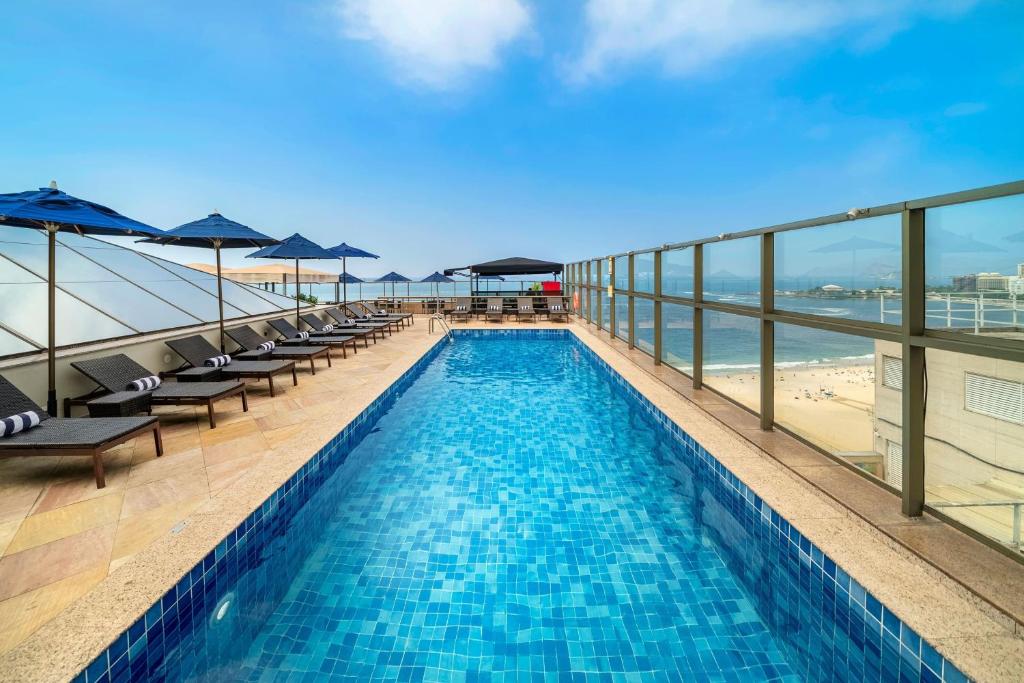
[71,353,249,429]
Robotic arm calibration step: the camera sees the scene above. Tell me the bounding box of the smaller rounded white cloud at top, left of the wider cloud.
[333,0,530,89]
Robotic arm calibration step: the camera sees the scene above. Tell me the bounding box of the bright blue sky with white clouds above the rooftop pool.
[0,0,1024,276]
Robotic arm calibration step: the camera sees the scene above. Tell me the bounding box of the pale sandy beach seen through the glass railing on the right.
[705,358,874,453]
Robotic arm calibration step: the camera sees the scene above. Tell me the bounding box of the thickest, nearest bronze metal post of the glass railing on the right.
[900,209,926,517]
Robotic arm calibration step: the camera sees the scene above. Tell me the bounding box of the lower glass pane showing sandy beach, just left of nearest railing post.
[774,324,884,487]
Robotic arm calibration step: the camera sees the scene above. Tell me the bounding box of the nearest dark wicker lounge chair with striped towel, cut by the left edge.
[0,377,164,488]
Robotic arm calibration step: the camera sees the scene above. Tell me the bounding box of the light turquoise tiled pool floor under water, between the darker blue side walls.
[230,337,795,681]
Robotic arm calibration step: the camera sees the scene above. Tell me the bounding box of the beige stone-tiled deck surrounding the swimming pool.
[0,317,1024,682]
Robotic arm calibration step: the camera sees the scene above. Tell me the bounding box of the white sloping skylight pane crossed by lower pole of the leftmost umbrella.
[0,281,135,347]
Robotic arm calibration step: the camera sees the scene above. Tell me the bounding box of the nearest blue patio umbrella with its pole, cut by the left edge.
[0,182,164,415]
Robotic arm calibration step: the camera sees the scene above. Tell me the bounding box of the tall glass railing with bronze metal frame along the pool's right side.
[566,181,1024,550]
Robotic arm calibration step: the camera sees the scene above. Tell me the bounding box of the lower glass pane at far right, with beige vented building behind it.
[921,345,1024,550]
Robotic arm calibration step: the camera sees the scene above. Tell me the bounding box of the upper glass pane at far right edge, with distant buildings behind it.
[925,196,1024,340]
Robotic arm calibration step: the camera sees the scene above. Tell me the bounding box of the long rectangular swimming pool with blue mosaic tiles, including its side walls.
[75,331,963,682]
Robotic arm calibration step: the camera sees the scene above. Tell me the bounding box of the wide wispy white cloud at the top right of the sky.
[566,0,975,83]
